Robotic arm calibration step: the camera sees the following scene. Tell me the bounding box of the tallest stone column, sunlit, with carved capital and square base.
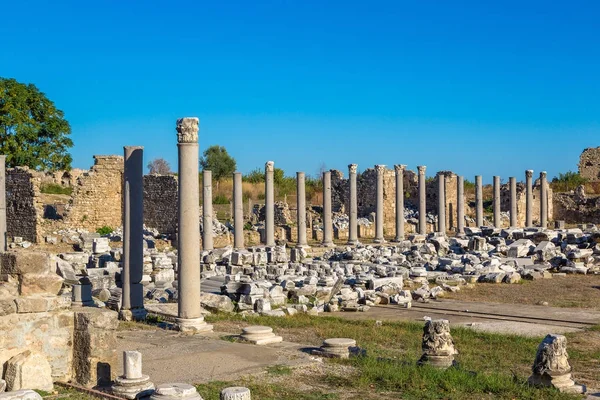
[176,118,212,332]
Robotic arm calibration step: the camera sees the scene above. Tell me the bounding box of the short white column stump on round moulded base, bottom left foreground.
[111,351,154,399]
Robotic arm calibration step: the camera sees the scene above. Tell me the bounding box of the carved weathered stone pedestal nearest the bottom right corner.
[528,335,586,394]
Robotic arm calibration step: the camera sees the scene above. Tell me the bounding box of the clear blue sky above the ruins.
[0,0,600,181]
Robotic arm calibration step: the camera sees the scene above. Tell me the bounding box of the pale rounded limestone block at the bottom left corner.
[4,350,54,391]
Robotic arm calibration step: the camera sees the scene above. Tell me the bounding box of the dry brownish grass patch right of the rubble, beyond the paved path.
[446,275,600,310]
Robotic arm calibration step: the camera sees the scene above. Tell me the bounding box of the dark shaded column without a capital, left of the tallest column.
[119,146,146,321]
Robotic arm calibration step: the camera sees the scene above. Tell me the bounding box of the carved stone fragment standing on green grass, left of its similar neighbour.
[419,319,457,369]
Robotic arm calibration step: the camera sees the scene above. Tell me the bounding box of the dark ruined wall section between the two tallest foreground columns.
[144,175,179,234]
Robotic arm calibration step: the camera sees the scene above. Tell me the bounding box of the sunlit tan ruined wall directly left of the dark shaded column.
[65,156,123,230]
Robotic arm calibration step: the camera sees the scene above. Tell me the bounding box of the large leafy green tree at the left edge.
[0,77,73,170]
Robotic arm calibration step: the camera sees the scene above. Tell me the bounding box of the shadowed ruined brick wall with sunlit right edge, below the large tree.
[6,167,43,243]
